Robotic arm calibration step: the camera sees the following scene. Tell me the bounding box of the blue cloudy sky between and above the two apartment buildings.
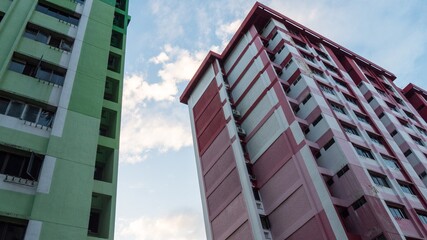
[115,0,427,240]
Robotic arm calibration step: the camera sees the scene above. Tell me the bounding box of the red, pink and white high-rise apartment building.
[181,3,427,240]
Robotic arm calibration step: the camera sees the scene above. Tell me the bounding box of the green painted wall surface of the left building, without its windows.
[0,0,130,240]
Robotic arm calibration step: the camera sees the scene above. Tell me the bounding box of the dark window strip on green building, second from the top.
[24,25,73,52]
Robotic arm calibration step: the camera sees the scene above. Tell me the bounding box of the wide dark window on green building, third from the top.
[9,54,66,86]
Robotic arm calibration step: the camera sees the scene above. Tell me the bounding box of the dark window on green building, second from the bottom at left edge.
[0,149,44,181]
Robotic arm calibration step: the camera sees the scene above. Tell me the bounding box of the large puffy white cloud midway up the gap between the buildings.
[120,74,192,163]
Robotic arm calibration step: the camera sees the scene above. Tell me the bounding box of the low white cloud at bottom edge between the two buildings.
[116,213,205,240]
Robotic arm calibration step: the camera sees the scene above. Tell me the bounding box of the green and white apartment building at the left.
[0,0,130,240]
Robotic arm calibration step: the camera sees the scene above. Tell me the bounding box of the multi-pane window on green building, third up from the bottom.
[0,97,55,128]
